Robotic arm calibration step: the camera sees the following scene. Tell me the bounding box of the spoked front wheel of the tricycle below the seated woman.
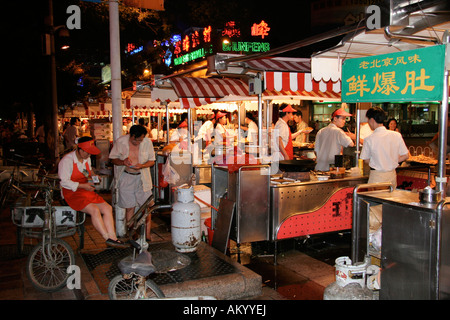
[27,239,75,292]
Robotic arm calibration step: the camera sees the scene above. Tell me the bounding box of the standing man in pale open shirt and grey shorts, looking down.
[109,125,156,235]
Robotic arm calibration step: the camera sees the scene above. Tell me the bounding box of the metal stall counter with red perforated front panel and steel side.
[211,166,367,243]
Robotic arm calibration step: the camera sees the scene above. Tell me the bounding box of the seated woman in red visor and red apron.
[58,137,128,248]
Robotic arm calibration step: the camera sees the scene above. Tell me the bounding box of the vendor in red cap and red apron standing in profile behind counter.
[272,103,297,161]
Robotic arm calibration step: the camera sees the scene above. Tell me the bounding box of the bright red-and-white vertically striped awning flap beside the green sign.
[263,71,341,99]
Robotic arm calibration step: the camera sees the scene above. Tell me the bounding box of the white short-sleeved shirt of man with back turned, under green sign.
[360,126,408,172]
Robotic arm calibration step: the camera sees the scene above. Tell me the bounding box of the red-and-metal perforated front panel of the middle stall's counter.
[270,176,367,240]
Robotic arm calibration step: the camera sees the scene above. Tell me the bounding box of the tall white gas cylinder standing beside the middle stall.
[171,187,201,253]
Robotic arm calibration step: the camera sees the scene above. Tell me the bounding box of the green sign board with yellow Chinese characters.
[341,45,445,103]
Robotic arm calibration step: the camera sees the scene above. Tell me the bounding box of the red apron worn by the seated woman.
[62,162,105,211]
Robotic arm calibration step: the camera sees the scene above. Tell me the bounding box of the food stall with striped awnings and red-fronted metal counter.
[151,58,367,259]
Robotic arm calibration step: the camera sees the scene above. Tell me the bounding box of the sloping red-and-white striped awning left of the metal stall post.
[171,77,249,108]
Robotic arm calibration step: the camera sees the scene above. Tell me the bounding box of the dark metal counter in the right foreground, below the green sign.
[352,189,450,300]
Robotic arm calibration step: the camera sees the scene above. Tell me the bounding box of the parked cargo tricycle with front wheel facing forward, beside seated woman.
[12,184,85,292]
